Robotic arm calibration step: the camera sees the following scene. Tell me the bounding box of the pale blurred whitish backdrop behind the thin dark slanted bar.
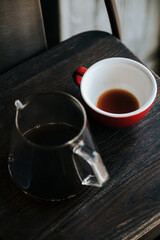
[59,0,160,75]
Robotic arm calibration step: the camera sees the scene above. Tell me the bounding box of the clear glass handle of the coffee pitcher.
[73,140,109,187]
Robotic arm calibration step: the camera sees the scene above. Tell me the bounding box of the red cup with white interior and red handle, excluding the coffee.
[73,57,157,128]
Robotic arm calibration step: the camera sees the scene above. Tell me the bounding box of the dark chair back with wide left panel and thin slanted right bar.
[0,0,120,73]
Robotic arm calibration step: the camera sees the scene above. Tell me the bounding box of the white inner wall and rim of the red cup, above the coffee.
[80,58,157,116]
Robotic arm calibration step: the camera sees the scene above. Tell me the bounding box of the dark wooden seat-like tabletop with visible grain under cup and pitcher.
[0,32,160,240]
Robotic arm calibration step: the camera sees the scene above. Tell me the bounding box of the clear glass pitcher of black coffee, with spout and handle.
[8,92,109,201]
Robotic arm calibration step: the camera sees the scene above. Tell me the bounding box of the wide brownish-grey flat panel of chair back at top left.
[0,0,47,72]
